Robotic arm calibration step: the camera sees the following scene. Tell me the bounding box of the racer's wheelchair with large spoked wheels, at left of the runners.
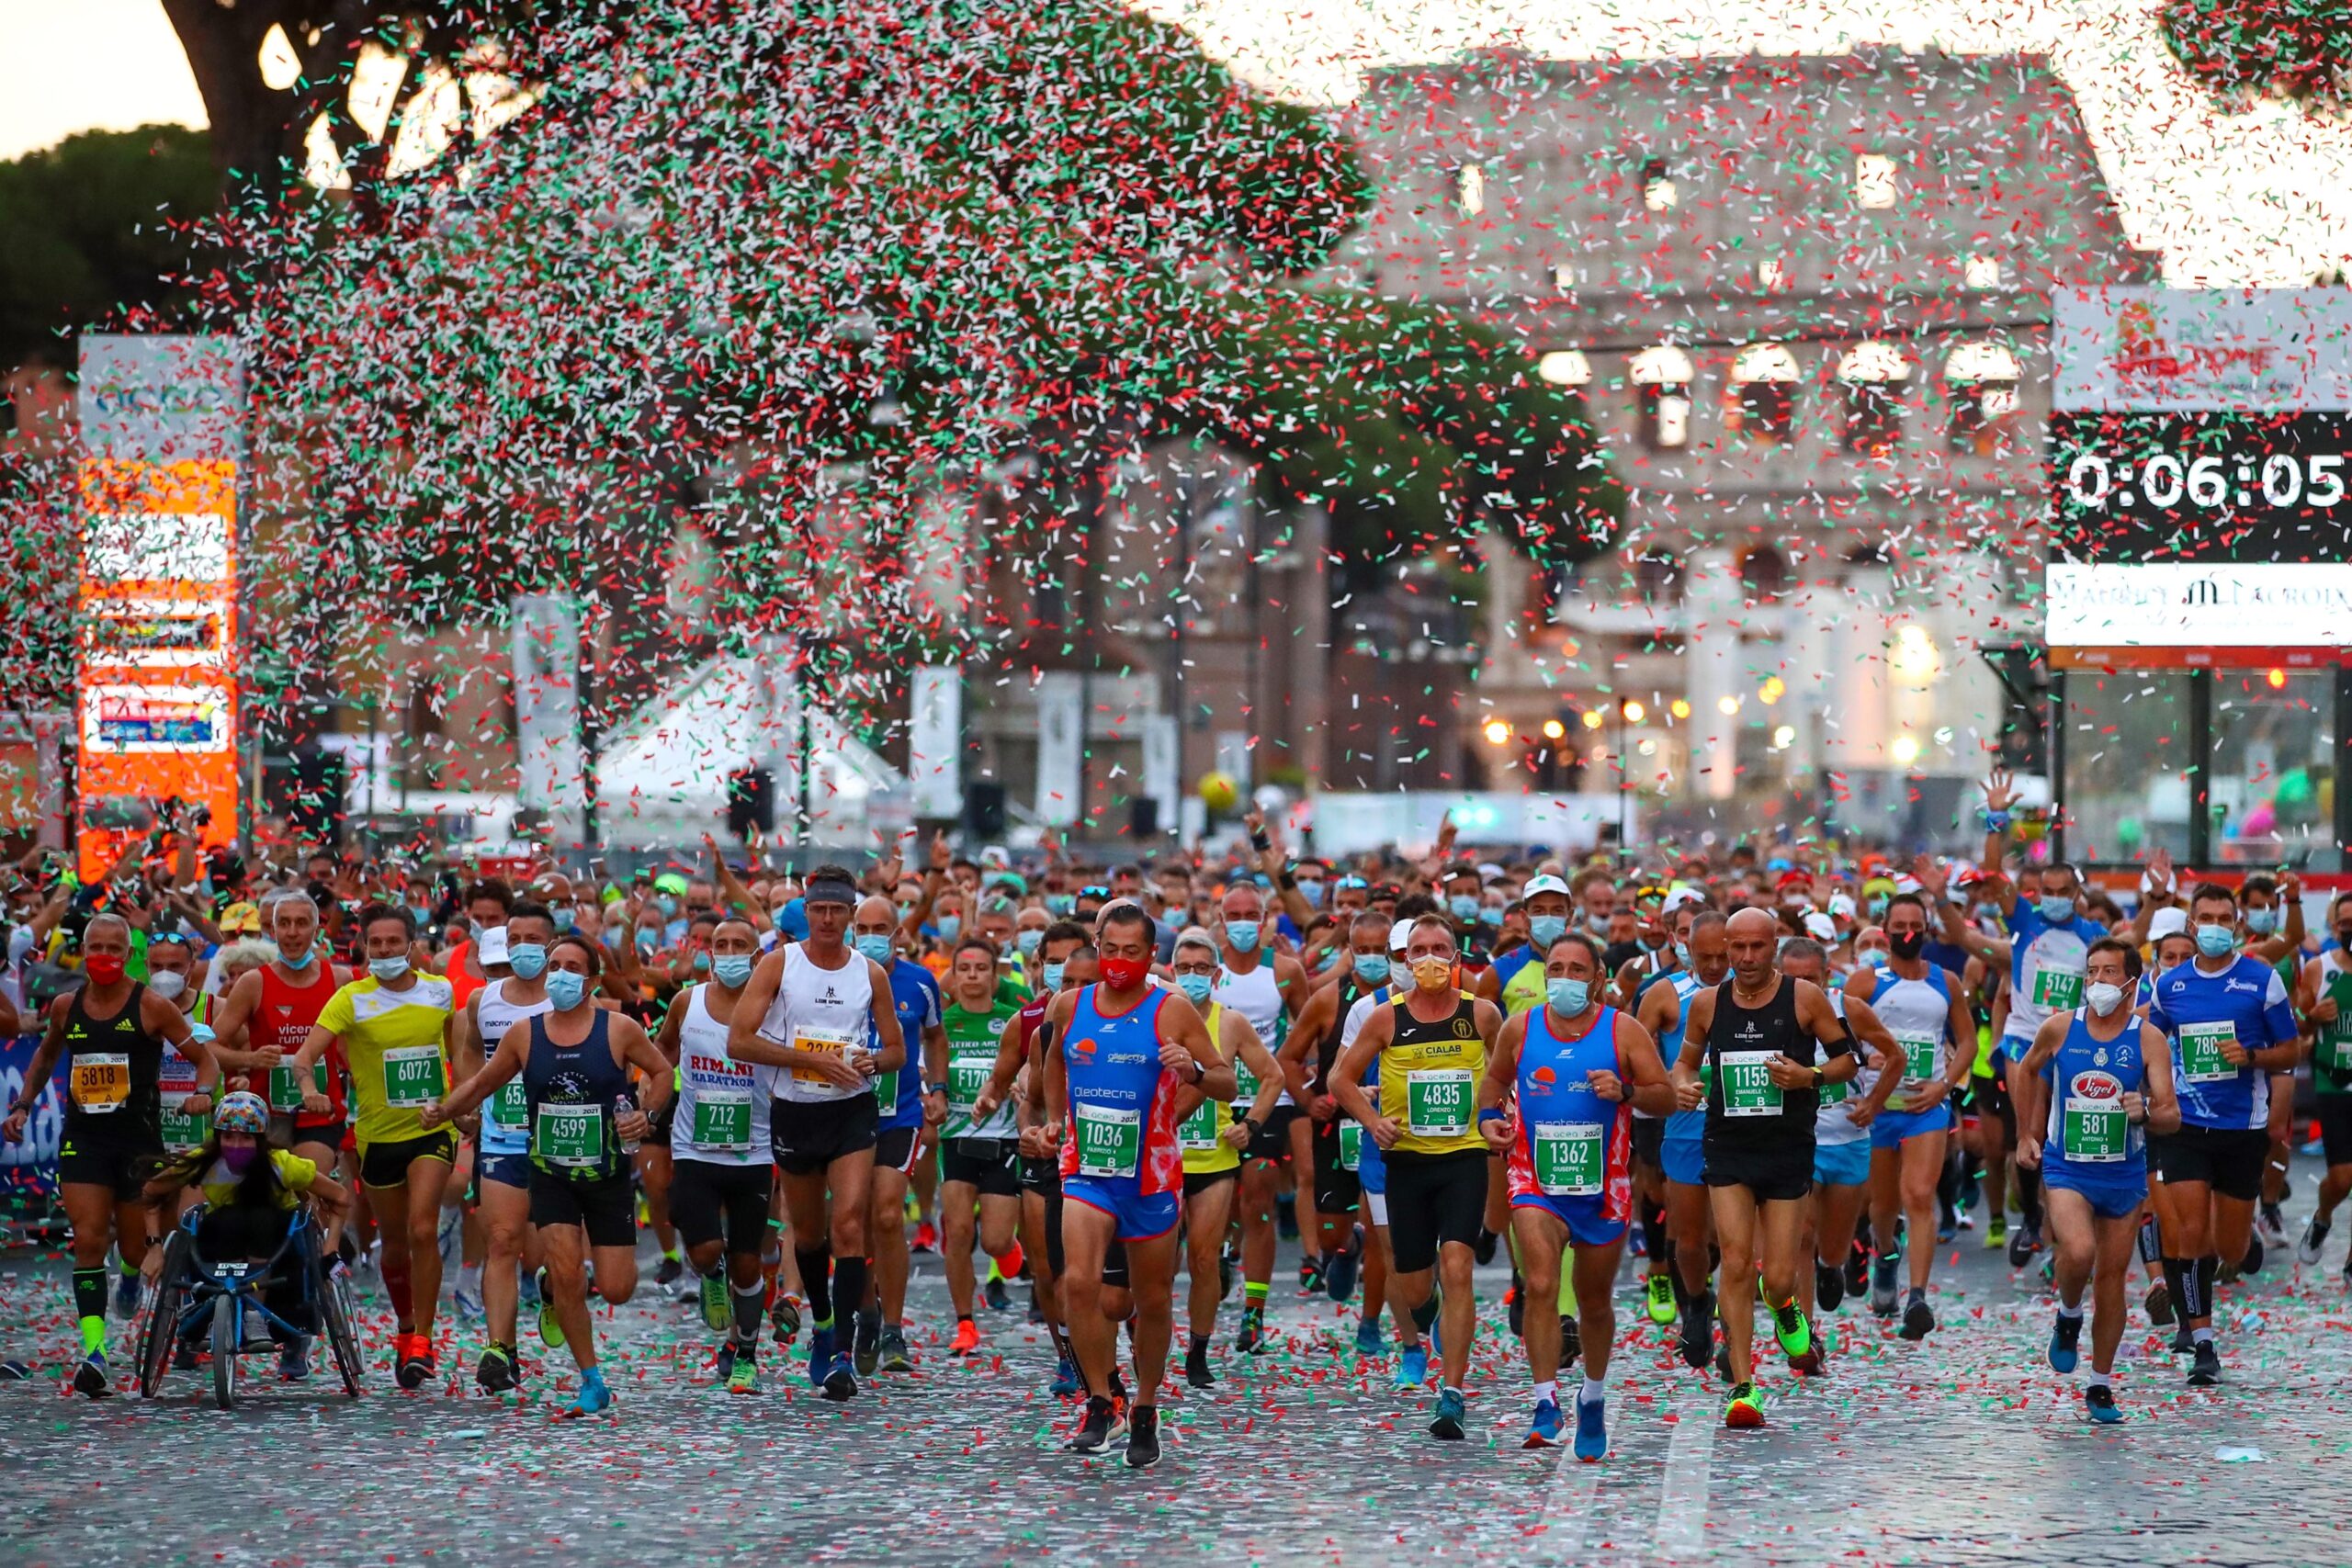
[139,1203,360,1411]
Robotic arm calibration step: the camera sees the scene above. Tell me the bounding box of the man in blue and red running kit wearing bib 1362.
[1479,931,1675,1462]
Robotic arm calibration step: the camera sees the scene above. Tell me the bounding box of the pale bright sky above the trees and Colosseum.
[0,0,2352,287]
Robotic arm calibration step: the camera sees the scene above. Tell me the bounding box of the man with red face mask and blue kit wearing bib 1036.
[1045,900,1235,1470]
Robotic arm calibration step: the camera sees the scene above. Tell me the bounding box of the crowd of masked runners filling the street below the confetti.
[0,776,2352,1467]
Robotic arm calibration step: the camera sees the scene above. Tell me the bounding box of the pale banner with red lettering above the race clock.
[2051,287,2352,413]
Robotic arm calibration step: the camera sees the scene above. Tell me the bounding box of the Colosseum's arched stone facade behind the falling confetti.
[1339,50,2157,829]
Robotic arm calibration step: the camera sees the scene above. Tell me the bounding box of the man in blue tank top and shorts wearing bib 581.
[2018,936,2180,1422]
